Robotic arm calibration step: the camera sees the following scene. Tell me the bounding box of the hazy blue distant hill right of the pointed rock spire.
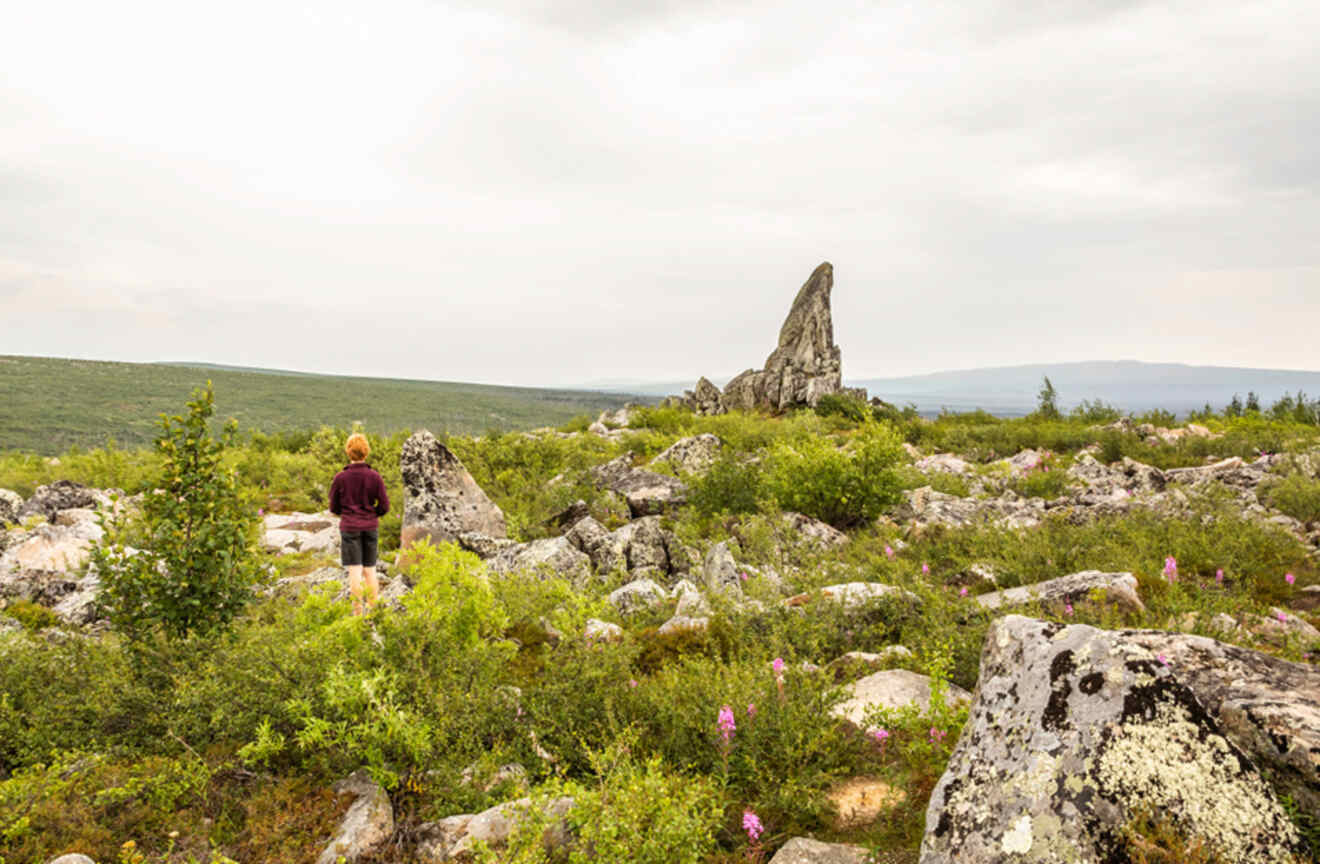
[847,360,1320,417]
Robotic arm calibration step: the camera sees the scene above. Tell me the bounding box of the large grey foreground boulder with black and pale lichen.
[920,615,1300,864]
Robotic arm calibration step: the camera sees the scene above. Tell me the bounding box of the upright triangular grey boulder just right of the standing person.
[399,430,508,547]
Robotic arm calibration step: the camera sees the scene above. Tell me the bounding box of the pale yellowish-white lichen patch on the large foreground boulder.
[1097,703,1298,861]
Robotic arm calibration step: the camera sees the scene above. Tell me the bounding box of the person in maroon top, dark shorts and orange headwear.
[330,433,389,615]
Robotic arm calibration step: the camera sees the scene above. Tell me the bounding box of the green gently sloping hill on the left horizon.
[0,355,636,454]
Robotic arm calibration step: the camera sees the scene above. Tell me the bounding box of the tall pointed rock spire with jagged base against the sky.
[682,261,865,414]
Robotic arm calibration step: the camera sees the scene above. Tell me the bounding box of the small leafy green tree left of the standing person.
[94,381,261,641]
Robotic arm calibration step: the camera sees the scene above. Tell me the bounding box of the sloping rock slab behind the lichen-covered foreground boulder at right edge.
[1122,627,1320,813]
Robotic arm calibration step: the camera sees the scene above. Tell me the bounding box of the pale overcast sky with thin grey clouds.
[0,0,1320,384]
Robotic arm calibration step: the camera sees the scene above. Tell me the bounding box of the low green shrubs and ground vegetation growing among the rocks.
[0,387,1320,864]
